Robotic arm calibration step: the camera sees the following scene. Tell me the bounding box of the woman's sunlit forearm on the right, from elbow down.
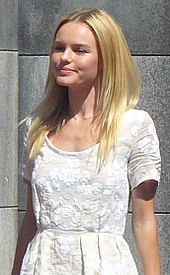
[132,214,161,275]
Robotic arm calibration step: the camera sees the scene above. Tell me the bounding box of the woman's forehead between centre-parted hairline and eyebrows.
[55,22,96,45]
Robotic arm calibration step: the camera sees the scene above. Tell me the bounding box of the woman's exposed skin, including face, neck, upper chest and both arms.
[12,22,161,275]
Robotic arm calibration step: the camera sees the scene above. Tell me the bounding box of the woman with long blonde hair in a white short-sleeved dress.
[12,9,161,275]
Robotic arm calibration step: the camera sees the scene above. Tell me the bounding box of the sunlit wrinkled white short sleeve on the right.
[128,111,161,190]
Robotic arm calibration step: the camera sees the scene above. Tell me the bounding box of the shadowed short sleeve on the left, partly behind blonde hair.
[19,118,33,181]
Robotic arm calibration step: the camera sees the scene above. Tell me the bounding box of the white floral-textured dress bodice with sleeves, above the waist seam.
[21,110,160,235]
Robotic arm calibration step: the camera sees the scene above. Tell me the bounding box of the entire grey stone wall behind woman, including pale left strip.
[0,0,170,275]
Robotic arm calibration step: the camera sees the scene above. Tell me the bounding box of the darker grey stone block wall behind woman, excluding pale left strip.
[19,0,170,275]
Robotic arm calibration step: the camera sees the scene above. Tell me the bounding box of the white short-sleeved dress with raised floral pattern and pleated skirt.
[20,109,160,275]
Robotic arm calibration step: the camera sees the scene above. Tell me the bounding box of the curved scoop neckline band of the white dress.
[45,136,99,156]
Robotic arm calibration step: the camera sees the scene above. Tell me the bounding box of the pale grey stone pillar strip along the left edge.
[0,0,18,275]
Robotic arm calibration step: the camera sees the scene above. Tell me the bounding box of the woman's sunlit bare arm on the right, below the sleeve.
[132,180,161,275]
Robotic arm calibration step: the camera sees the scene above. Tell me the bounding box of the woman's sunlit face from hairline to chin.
[52,22,98,90]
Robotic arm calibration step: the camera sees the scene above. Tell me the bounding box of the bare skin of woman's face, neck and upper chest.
[49,22,101,152]
